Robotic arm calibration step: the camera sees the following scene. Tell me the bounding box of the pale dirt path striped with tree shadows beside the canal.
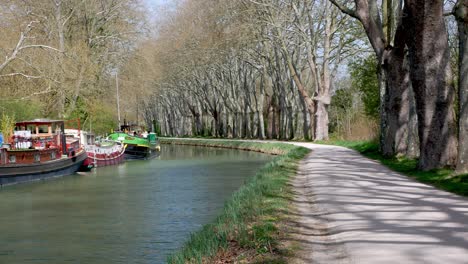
[293,143,468,264]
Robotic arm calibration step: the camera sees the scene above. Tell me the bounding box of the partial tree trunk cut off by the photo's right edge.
[455,0,468,172]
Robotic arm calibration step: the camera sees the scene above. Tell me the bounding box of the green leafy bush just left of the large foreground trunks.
[349,56,380,120]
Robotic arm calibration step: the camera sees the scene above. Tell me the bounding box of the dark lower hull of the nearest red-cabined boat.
[0,151,87,186]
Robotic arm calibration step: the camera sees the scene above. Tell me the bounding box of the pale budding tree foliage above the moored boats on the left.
[0,0,146,119]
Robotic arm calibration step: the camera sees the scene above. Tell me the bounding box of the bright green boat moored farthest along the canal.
[107,132,161,160]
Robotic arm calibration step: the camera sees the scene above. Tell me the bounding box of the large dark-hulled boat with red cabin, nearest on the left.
[0,119,87,185]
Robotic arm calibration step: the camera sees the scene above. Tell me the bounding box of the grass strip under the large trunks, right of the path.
[319,140,468,196]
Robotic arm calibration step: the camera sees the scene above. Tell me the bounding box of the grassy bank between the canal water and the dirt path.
[161,139,310,263]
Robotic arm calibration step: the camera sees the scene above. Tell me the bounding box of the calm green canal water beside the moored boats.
[0,145,272,264]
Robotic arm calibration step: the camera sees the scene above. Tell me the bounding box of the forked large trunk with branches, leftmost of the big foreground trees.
[329,0,409,156]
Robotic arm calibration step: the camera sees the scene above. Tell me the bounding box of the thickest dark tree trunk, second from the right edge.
[405,0,457,171]
